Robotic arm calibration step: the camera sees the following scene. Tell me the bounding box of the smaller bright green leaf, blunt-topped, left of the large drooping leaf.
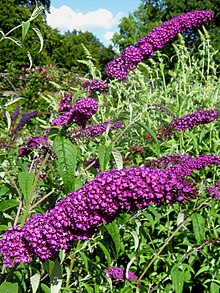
[18,172,34,204]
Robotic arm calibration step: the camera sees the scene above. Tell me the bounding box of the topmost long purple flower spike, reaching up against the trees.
[106,10,214,80]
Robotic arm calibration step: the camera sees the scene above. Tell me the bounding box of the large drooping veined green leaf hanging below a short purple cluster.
[53,135,77,192]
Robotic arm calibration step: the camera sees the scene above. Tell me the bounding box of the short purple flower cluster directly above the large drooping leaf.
[51,97,98,128]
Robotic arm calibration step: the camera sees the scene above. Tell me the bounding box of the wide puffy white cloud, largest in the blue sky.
[47,5,123,32]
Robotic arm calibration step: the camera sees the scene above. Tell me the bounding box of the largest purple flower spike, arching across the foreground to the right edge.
[0,155,220,267]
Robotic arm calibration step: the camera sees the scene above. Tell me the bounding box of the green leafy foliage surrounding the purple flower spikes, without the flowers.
[0,10,220,293]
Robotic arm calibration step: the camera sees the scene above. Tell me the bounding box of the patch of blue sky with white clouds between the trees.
[47,0,141,45]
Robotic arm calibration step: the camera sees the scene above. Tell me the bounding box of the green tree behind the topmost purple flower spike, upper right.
[113,0,220,57]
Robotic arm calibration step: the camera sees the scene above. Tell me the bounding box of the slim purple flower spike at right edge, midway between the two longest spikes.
[157,109,219,141]
